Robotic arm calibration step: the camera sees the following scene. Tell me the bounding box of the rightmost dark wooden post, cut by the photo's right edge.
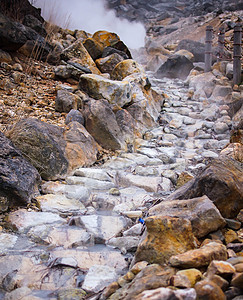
[233,23,242,85]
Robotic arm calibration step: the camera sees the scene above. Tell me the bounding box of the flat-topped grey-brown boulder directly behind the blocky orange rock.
[149,196,226,238]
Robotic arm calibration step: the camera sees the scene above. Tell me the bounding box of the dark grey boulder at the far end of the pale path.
[156,55,193,80]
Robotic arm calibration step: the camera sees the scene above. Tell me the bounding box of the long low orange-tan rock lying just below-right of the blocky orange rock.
[169,242,227,268]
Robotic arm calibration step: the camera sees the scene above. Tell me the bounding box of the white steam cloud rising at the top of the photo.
[32,0,146,49]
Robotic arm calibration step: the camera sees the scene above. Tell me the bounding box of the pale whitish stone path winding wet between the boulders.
[0,74,234,299]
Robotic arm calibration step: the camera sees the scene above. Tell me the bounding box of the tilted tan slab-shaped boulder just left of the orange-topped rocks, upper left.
[61,40,100,74]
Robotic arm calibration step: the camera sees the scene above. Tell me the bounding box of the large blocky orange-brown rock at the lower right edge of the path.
[135,216,197,264]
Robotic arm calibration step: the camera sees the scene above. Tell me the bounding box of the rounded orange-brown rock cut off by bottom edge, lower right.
[194,280,226,300]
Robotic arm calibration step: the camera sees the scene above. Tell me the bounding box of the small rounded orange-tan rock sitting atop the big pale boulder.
[111,59,144,80]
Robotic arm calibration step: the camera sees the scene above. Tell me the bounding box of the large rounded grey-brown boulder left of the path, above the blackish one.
[8,118,68,180]
